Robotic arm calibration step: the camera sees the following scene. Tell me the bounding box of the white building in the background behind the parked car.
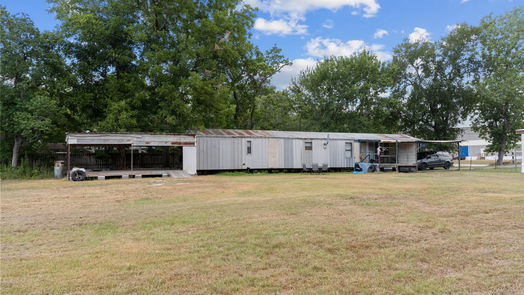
[457,127,524,161]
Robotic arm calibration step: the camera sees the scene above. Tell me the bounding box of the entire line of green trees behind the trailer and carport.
[0,0,524,166]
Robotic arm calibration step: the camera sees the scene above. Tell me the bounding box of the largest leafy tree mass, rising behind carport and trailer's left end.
[51,0,282,132]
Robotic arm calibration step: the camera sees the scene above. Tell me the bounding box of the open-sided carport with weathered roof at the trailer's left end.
[66,133,196,179]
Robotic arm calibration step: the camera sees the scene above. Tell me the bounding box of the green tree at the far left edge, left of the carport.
[0,7,66,167]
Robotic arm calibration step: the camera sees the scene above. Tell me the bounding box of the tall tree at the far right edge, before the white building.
[473,7,524,165]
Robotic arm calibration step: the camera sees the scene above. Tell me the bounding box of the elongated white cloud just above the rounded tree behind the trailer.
[306,37,391,60]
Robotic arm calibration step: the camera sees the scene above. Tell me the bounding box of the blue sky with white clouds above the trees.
[2,0,524,88]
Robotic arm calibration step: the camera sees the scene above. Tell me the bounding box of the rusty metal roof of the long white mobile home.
[196,129,421,142]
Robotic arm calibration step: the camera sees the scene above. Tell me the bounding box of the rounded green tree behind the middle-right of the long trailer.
[290,51,399,132]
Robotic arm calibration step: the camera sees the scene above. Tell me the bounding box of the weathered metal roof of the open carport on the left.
[66,133,195,146]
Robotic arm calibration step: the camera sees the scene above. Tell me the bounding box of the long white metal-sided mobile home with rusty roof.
[196,129,420,171]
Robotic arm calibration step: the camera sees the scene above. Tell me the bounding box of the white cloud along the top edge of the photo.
[244,0,380,17]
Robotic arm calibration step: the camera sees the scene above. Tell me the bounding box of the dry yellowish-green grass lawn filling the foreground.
[1,170,524,294]
